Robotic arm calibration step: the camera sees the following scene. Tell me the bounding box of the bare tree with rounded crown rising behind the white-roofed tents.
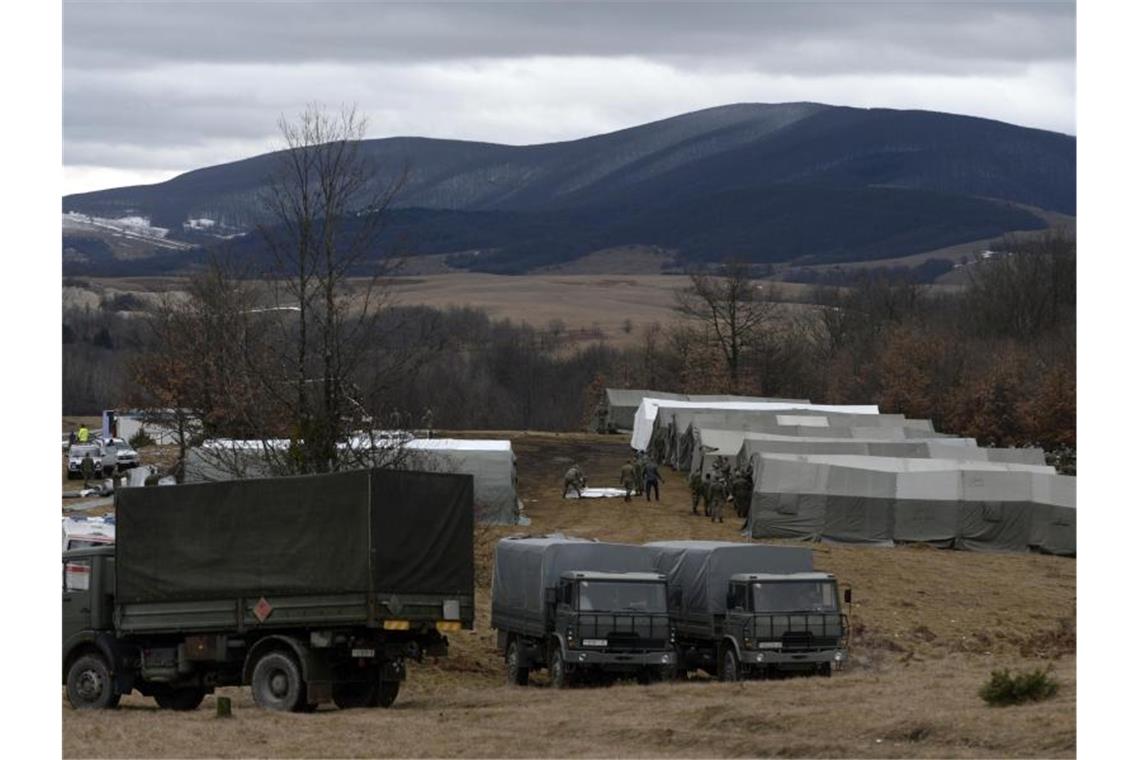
[676,261,777,391]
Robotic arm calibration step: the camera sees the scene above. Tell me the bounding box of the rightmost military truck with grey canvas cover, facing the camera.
[645,541,850,681]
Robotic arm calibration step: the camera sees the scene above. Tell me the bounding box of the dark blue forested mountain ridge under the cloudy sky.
[63,103,1076,271]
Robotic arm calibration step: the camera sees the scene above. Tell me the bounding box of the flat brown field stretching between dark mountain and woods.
[64,272,811,345]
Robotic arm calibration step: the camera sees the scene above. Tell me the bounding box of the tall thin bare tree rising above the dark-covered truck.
[250,106,406,473]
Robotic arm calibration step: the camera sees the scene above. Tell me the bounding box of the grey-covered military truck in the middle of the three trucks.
[491,536,675,688]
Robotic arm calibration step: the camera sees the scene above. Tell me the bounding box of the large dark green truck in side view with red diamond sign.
[63,469,474,711]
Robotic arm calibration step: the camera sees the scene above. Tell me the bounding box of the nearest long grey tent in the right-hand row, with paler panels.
[748,453,1076,554]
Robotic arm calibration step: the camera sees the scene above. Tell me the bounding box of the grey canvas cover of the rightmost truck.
[645,541,812,616]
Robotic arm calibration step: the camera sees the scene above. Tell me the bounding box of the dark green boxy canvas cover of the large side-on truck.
[115,469,474,604]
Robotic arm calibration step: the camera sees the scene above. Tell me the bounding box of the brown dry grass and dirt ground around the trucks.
[63,433,1076,758]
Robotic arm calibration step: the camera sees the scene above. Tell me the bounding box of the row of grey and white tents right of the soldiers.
[611,392,1076,555]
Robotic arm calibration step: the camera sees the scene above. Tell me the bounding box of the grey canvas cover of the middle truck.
[491,536,658,624]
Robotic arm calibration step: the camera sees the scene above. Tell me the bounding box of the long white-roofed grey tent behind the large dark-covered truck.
[186,436,519,524]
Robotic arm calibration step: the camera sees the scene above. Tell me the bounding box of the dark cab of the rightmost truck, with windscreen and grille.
[717,572,850,680]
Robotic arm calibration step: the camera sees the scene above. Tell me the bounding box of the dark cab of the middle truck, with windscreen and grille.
[551,571,675,683]
